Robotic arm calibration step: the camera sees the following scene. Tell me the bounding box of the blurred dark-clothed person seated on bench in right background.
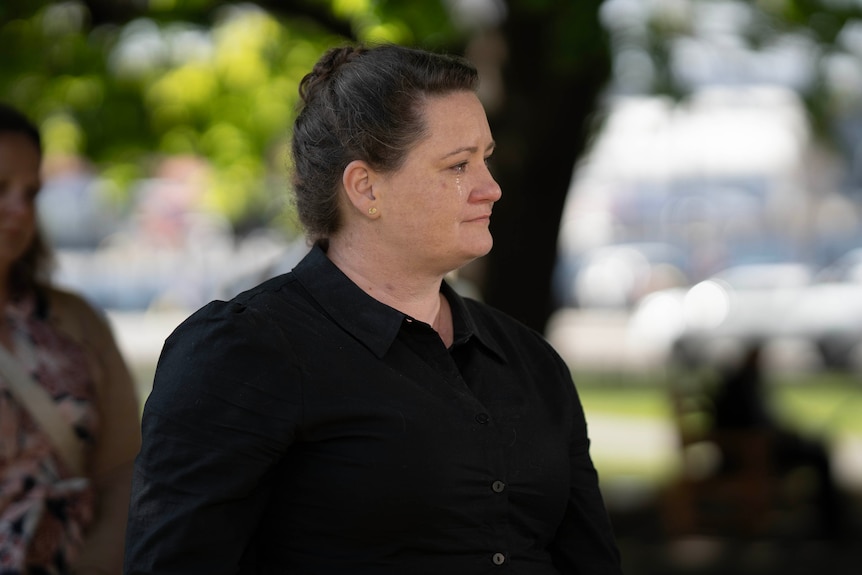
[712,341,847,539]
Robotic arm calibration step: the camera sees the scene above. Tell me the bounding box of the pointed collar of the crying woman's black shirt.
[293,245,504,359]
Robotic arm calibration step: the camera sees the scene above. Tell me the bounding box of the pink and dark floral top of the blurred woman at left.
[0,297,100,575]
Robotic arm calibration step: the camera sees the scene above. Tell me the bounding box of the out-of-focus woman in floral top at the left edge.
[0,101,140,575]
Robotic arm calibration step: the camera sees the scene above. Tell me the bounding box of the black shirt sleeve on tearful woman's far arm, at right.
[551,360,622,575]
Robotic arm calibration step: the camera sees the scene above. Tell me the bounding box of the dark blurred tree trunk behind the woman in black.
[480,0,610,332]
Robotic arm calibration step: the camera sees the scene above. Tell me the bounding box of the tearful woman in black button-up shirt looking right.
[125,45,620,575]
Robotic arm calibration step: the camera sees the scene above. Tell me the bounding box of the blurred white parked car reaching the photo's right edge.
[629,262,862,369]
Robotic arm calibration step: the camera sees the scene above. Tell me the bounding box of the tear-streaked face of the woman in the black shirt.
[375,91,501,274]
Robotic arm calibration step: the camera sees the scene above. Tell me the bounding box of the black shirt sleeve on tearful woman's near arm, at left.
[125,302,299,575]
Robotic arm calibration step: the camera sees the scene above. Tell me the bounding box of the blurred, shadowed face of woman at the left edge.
[0,132,42,272]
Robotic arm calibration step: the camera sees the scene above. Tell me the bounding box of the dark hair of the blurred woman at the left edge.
[0,103,51,298]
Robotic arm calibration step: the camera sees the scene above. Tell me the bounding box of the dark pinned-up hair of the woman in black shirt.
[292,44,479,242]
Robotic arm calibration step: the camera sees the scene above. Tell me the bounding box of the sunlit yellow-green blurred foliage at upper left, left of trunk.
[0,0,470,233]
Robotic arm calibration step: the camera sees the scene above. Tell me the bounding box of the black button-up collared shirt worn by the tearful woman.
[125,248,620,575]
